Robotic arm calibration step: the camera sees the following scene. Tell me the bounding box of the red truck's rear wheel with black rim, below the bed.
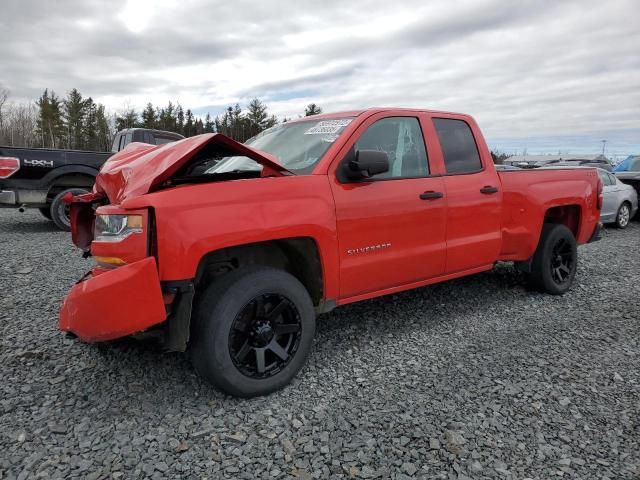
[529,223,578,295]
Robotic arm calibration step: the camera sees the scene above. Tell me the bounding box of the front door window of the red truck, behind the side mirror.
[355,117,429,179]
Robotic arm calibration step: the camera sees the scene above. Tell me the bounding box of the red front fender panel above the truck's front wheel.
[122,175,338,299]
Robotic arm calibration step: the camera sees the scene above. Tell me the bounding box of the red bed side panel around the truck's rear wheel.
[498,169,600,260]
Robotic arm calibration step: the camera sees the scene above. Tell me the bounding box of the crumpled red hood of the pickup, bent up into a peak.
[94,133,291,203]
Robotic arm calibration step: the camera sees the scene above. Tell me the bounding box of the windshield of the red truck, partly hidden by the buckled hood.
[205,118,353,174]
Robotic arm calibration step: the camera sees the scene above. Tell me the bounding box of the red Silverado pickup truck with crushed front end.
[60,108,602,396]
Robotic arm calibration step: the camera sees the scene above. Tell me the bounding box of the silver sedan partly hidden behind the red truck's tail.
[598,168,638,228]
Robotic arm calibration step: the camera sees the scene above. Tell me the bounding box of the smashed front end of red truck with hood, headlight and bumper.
[59,134,289,351]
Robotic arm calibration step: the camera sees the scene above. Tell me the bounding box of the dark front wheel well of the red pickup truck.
[195,237,324,306]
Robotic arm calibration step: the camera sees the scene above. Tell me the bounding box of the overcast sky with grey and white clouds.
[0,0,640,153]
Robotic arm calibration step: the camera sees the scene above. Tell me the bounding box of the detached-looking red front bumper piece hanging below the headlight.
[59,257,167,342]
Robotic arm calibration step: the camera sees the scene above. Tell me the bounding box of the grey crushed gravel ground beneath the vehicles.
[0,210,640,479]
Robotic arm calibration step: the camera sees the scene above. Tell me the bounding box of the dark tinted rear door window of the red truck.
[433,118,482,173]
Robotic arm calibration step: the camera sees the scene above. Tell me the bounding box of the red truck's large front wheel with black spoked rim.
[189,267,315,397]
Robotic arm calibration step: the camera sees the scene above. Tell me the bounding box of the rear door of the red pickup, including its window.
[432,115,502,273]
